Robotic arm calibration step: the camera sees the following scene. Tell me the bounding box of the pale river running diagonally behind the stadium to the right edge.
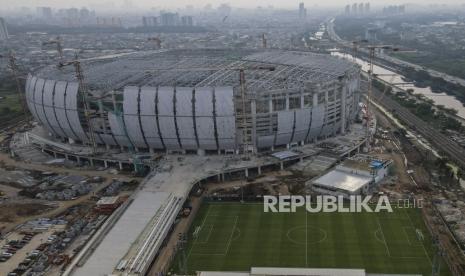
[331,52,465,119]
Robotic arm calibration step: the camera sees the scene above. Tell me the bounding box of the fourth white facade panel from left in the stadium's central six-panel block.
[176,87,198,149]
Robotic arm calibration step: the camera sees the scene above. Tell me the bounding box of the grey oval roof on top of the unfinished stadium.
[36,49,358,91]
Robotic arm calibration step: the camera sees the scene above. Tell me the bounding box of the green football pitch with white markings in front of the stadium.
[172,203,451,275]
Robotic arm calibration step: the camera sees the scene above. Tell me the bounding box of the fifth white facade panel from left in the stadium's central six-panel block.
[195,87,217,150]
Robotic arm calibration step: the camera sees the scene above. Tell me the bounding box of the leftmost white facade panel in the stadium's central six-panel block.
[123,86,147,148]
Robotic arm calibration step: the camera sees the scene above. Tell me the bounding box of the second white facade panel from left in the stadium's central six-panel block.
[140,87,163,149]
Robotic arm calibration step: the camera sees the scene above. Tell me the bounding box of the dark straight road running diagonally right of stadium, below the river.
[372,91,465,169]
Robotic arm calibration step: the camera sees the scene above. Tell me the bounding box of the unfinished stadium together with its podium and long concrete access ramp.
[16,49,366,276]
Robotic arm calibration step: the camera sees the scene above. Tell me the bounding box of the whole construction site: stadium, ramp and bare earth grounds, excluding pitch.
[0,39,462,276]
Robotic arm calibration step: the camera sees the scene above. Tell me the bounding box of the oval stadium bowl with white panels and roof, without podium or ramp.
[26,49,360,154]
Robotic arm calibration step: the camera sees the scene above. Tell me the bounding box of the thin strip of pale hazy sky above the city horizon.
[0,0,465,8]
